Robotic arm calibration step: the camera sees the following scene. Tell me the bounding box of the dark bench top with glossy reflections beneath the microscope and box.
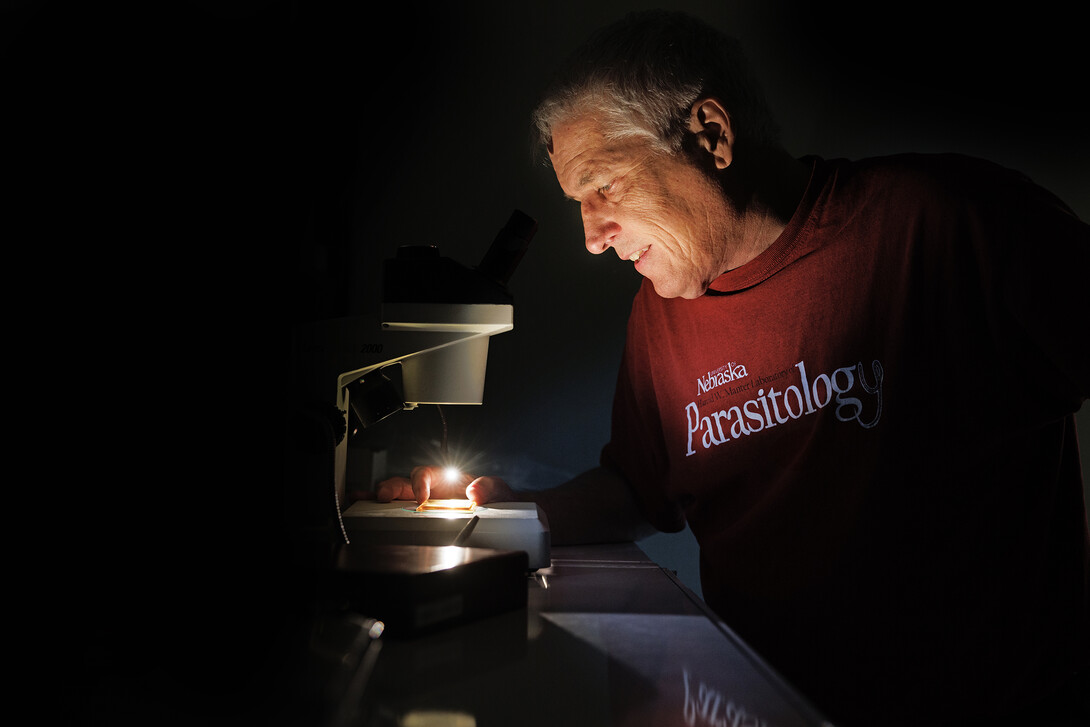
[290,544,825,727]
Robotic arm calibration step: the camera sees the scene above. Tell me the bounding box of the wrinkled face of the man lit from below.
[549,116,734,298]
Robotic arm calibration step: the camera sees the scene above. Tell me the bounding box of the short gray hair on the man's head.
[533,11,779,160]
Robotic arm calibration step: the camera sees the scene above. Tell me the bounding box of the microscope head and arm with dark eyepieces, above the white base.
[288,210,536,549]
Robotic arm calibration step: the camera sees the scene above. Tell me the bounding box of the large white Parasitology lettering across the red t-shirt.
[686,359,884,457]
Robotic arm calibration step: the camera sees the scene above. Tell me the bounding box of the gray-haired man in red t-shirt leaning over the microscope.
[379,13,1090,726]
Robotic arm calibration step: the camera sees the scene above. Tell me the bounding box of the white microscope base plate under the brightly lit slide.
[342,500,550,570]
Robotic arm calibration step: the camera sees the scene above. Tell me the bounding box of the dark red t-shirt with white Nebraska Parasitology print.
[603,156,1090,725]
